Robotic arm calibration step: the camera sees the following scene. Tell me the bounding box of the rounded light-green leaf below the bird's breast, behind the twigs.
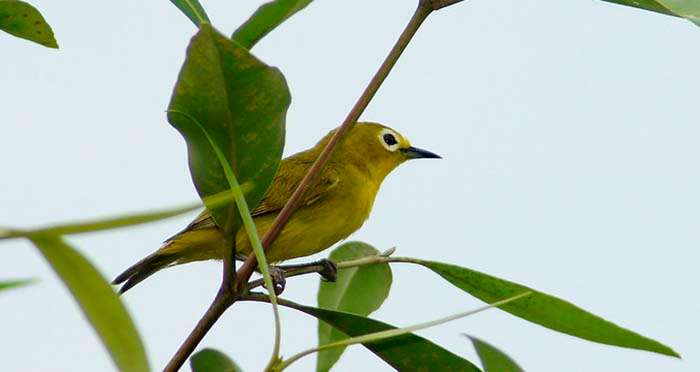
[316,242,392,371]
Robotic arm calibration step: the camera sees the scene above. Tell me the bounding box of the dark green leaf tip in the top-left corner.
[0,0,58,49]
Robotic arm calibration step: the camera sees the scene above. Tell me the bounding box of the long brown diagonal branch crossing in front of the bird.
[164,0,462,372]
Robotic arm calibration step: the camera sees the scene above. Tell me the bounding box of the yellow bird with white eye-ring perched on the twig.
[114,123,440,293]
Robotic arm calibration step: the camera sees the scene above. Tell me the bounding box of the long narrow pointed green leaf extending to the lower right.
[411,259,680,357]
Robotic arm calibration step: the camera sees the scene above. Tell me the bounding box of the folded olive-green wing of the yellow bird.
[166,153,340,238]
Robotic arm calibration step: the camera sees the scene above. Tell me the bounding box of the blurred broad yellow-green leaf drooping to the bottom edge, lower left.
[30,234,149,372]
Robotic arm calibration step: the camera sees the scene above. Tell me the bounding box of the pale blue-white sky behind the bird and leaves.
[0,0,700,372]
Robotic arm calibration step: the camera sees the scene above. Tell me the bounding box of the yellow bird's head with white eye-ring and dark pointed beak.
[322,122,440,181]
